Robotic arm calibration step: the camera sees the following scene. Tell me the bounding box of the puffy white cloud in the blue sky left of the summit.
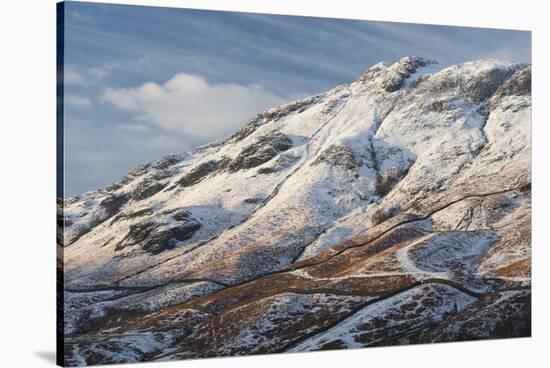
[102,73,285,139]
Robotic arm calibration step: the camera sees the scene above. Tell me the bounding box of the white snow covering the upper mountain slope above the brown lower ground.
[64,56,530,286]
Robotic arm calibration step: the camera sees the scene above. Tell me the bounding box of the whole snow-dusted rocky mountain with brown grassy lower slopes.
[58,57,531,365]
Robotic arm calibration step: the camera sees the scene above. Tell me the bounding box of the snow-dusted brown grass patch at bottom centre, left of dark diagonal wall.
[168,292,368,359]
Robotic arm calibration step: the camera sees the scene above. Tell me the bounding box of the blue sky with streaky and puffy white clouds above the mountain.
[64,2,531,195]
